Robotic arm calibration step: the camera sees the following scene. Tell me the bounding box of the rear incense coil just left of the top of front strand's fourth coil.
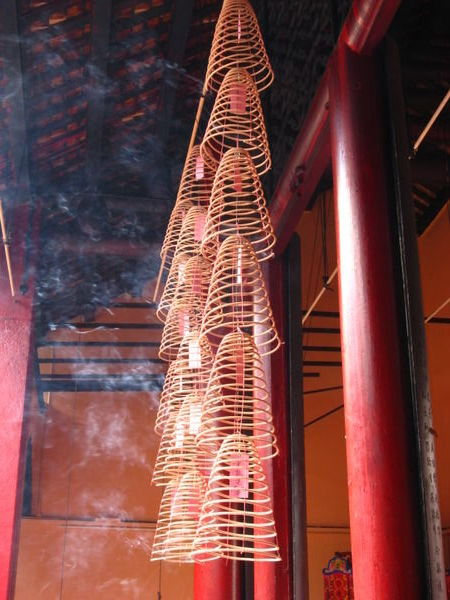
[156,253,212,321]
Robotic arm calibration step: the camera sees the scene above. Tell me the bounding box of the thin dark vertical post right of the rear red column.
[284,234,309,600]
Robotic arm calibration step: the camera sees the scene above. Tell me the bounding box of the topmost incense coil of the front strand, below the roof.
[206,0,273,92]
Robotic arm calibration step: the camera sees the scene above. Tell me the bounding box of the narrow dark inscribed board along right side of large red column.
[385,40,450,600]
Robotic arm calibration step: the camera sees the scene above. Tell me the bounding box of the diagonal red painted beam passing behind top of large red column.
[270,0,400,254]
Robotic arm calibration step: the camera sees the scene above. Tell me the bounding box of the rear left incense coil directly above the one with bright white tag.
[159,293,204,361]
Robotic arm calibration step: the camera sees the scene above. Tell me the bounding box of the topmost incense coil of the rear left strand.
[177,145,214,206]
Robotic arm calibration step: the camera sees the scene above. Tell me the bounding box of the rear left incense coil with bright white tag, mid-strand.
[155,330,213,435]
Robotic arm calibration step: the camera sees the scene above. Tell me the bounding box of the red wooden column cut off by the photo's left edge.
[0,204,33,600]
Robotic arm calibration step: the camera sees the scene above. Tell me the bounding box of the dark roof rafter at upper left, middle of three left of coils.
[86,0,112,190]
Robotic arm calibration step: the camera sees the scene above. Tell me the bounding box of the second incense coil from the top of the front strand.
[201,69,271,175]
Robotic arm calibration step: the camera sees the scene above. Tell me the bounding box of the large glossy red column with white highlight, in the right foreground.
[330,42,425,600]
